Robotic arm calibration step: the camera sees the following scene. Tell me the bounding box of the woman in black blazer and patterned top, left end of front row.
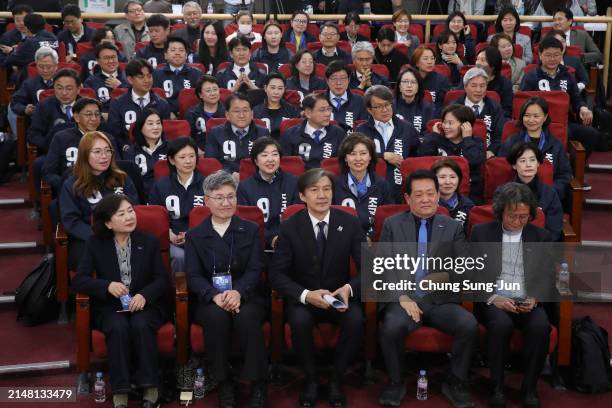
[72,194,168,407]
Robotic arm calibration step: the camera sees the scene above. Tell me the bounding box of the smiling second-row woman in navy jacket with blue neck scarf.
[333,132,394,239]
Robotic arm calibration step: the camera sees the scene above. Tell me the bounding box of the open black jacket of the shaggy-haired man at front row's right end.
[470,221,558,301]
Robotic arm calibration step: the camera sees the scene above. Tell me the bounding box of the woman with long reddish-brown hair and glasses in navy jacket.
[59,132,138,270]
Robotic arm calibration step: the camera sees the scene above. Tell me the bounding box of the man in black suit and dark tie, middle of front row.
[270,168,365,407]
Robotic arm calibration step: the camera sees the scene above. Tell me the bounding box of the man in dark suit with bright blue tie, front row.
[379,170,478,407]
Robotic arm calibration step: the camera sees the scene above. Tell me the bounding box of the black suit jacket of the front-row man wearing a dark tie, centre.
[270,208,365,303]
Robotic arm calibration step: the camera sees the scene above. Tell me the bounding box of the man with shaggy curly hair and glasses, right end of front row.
[471,183,556,408]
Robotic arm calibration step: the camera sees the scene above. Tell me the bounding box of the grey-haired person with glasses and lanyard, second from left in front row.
[185,170,268,407]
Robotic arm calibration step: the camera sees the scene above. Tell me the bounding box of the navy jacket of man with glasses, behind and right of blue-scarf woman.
[357,117,419,203]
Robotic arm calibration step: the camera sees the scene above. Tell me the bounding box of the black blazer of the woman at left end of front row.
[72,230,168,314]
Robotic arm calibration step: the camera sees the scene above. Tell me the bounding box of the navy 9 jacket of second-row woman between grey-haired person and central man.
[238,170,301,247]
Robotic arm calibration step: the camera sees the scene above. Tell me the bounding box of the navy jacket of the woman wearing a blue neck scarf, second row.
[333,173,395,237]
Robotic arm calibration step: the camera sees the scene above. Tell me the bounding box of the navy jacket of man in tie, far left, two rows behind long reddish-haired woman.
[27,96,80,153]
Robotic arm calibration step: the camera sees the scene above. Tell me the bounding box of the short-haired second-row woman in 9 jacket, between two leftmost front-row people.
[149,137,204,272]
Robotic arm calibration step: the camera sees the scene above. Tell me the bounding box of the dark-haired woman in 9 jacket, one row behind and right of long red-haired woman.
[124,108,169,195]
